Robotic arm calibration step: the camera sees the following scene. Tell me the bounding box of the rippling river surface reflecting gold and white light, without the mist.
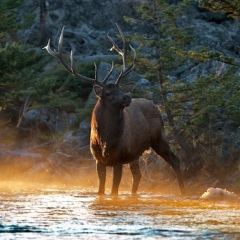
[0,184,240,239]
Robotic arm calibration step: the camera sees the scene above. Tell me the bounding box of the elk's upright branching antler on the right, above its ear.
[107,23,137,84]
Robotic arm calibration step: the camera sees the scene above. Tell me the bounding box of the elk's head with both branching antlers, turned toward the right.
[43,24,136,108]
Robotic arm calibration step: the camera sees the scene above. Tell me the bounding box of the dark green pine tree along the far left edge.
[0,0,46,109]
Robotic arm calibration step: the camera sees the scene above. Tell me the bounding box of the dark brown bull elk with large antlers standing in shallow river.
[44,24,185,195]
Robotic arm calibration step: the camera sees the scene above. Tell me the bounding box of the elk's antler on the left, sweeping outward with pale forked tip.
[43,27,99,84]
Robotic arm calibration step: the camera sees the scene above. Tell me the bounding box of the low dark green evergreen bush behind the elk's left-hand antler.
[24,63,94,113]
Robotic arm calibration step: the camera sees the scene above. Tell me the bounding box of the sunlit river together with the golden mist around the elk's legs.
[0,151,240,240]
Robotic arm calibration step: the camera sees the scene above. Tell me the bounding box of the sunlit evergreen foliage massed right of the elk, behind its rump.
[126,0,240,178]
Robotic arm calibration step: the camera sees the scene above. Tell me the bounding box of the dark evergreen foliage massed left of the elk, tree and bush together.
[0,0,94,117]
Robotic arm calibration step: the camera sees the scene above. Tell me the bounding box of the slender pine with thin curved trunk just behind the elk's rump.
[126,0,194,158]
